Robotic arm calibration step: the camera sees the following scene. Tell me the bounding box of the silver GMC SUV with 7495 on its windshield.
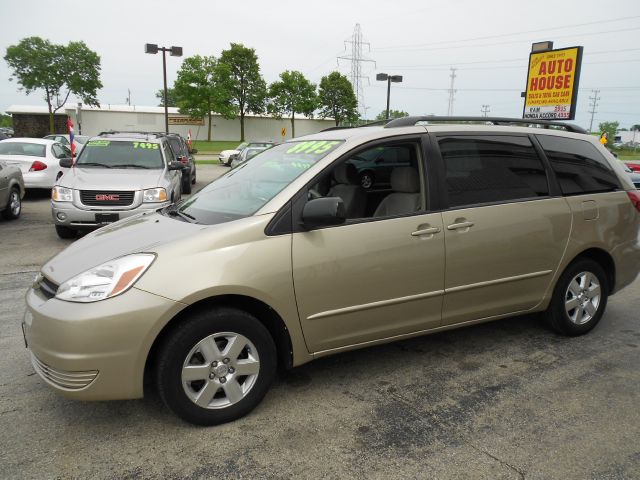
[51,132,182,238]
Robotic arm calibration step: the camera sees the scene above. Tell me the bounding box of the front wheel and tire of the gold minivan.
[156,308,277,425]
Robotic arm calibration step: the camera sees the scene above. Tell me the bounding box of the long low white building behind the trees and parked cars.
[7,104,335,141]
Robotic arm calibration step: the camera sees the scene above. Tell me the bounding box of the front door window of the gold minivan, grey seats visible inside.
[308,142,425,221]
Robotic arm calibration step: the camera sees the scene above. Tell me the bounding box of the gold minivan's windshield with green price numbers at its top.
[168,140,343,224]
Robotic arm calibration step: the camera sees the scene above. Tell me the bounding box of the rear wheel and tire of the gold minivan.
[547,258,609,336]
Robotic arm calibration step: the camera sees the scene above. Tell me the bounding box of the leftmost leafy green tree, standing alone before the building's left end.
[4,37,102,133]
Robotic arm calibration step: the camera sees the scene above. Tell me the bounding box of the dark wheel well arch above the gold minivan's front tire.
[144,295,293,392]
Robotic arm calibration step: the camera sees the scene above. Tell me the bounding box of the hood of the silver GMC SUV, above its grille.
[58,166,164,191]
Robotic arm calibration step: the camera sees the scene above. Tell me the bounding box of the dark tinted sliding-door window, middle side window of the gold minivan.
[438,135,549,207]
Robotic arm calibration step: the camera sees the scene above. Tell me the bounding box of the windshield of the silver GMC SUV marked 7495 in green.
[76,140,164,169]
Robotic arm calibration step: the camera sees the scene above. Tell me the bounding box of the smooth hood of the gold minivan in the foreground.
[42,213,202,284]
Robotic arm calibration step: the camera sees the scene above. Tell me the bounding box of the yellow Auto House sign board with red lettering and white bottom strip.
[522,47,582,120]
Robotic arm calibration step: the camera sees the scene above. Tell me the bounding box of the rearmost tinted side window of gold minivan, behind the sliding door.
[537,135,620,195]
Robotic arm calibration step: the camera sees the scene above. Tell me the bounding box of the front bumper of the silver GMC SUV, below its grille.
[51,201,171,229]
